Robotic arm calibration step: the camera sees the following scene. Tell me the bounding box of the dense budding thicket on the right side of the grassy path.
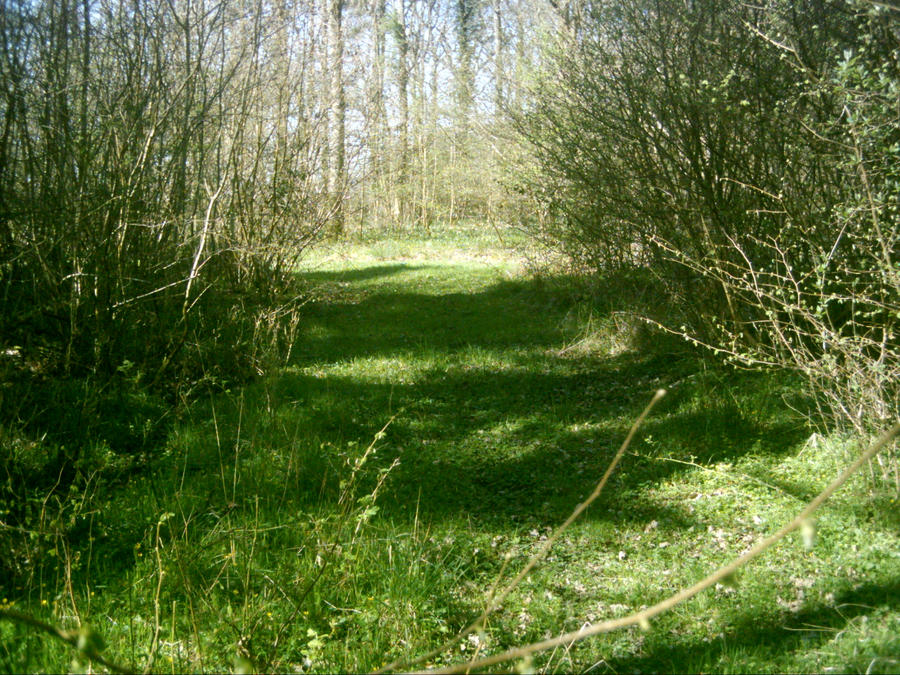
[519,0,900,444]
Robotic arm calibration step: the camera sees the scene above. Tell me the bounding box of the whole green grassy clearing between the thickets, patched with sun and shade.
[0,227,900,673]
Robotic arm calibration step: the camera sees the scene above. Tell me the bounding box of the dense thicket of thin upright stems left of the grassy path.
[0,0,342,489]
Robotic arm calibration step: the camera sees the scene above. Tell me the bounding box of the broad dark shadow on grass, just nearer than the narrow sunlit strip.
[275,356,802,526]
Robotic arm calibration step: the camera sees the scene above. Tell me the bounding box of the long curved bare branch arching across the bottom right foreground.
[427,422,900,673]
